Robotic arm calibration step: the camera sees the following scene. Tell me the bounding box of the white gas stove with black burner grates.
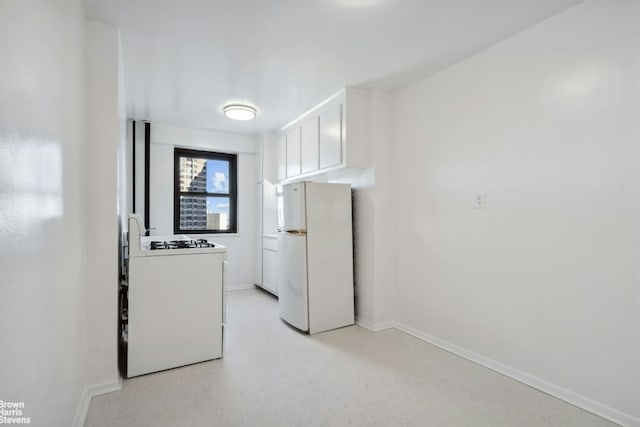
[126,214,227,378]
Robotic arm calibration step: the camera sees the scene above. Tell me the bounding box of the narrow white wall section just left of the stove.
[87,21,126,389]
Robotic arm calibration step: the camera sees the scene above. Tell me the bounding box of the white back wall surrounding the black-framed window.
[149,123,259,289]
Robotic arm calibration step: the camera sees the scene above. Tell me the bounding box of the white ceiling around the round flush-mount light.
[84,0,581,133]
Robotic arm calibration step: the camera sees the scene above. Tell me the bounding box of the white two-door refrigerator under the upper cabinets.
[278,182,354,334]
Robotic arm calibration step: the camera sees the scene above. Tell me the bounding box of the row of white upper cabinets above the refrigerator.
[278,88,371,181]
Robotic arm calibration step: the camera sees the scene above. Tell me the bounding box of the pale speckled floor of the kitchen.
[85,290,614,427]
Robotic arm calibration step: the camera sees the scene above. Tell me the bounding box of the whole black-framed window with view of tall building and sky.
[173,148,238,234]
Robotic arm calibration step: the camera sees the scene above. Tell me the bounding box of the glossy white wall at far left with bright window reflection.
[0,0,87,427]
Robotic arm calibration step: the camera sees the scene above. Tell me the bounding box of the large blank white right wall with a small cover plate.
[395,0,640,425]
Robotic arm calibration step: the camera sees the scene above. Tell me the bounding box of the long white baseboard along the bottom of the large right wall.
[394,322,640,427]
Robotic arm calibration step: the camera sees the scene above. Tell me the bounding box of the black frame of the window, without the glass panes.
[173,147,238,234]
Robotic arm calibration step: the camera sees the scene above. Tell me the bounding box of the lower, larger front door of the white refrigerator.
[278,231,309,331]
